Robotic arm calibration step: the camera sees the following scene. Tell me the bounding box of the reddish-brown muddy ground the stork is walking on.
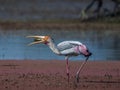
[0,60,120,90]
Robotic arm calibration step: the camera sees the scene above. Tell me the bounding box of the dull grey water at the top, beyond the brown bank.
[0,0,114,21]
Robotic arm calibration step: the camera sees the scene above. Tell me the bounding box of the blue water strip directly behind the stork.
[0,29,120,60]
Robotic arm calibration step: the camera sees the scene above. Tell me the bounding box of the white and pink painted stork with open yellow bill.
[27,36,92,82]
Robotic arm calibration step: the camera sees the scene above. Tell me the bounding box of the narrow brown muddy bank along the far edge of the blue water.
[0,22,120,30]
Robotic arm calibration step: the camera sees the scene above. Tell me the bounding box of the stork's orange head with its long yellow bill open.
[27,36,50,45]
